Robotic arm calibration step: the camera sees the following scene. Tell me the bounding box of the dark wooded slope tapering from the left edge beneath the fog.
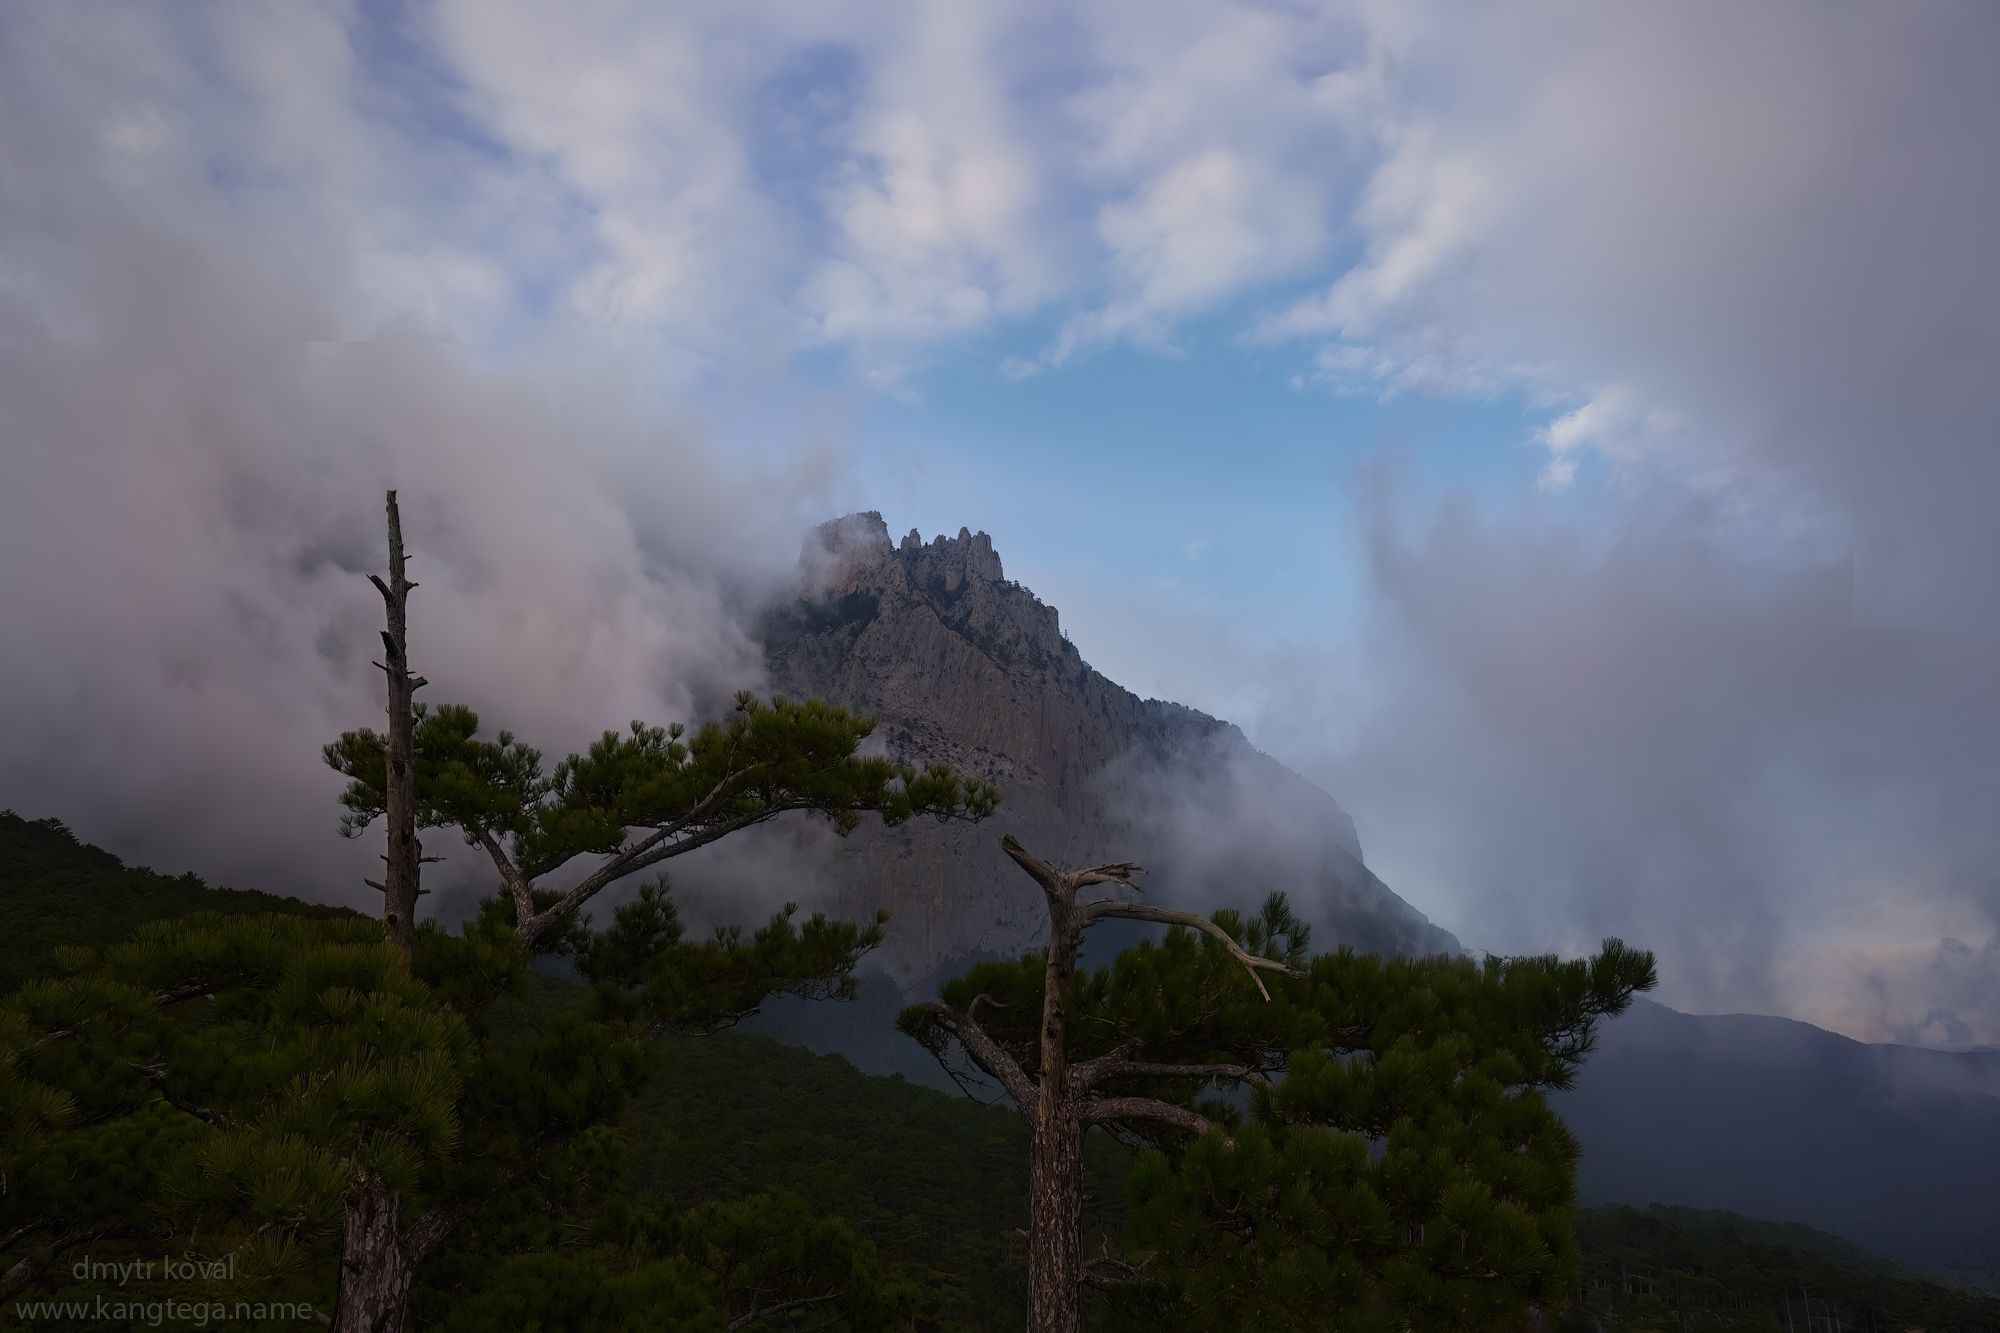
[0,811,346,991]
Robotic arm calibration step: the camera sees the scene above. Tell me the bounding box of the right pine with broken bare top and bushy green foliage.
[902,839,1654,1333]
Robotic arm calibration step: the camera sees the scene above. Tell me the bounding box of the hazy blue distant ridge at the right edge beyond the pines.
[1556,1001,2000,1291]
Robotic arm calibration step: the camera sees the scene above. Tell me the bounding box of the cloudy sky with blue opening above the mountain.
[0,0,2000,1045]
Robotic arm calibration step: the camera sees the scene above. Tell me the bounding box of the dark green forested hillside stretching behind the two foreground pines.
[0,813,2000,1333]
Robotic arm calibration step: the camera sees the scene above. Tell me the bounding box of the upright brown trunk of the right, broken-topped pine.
[1028,887,1084,1333]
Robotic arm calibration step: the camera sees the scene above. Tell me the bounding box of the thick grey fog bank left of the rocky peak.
[0,7,832,903]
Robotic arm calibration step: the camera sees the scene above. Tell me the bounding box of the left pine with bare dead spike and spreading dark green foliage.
[0,492,994,1333]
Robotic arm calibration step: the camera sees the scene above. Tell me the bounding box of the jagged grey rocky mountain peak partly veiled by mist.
[764,512,1458,991]
